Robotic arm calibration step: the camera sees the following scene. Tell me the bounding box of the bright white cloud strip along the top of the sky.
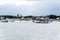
[0,0,41,5]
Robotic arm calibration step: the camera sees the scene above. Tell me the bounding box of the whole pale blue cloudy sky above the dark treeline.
[0,0,60,15]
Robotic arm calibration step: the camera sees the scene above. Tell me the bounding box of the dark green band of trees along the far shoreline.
[0,14,60,20]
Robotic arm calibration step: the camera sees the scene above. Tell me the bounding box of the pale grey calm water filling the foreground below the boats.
[0,22,60,40]
